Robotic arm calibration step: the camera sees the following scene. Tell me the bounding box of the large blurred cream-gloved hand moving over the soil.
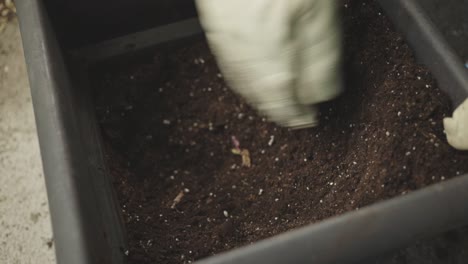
[196,0,342,128]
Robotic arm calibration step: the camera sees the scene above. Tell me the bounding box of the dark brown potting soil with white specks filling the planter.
[91,0,468,263]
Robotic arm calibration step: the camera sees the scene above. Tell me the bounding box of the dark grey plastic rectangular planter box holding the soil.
[17,0,468,264]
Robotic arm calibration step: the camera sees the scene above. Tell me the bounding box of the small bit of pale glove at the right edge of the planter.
[444,99,468,150]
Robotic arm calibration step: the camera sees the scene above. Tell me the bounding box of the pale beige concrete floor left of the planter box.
[0,20,55,264]
